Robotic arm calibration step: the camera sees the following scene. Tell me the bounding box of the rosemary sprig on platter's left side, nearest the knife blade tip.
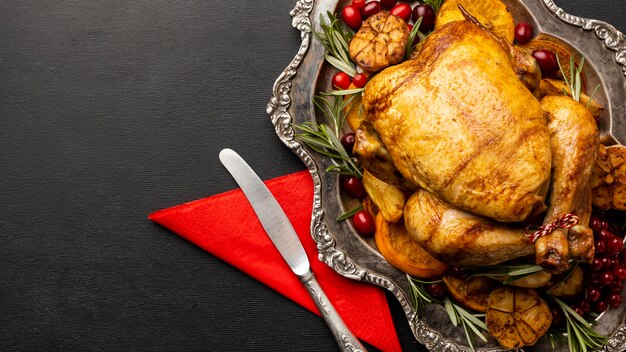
[294,122,363,177]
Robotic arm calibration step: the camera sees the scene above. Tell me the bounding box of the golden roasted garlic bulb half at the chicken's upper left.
[348,11,409,72]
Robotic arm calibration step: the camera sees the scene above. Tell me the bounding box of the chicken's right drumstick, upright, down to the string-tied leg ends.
[535,96,600,273]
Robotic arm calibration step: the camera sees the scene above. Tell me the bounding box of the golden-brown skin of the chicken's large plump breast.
[363,21,551,222]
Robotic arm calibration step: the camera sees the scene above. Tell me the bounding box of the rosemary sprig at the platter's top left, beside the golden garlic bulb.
[313,12,357,77]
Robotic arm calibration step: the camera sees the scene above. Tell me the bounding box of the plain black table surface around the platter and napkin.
[0,0,626,351]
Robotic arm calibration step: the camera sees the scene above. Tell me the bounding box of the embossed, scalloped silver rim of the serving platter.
[266,0,626,352]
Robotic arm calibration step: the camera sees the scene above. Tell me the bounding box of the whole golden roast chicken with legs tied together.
[354,11,599,273]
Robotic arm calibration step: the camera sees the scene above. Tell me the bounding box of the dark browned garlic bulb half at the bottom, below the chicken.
[485,286,552,349]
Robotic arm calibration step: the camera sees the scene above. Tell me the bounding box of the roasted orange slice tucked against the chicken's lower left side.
[374,212,448,279]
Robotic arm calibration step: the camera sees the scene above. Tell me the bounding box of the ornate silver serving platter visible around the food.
[267,0,626,352]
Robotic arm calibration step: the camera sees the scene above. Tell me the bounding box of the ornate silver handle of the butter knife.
[299,270,367,352]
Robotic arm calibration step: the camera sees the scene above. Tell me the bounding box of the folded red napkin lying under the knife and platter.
[149,171,401,351]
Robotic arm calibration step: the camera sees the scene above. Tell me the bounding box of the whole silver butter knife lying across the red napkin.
[219,149,365,352]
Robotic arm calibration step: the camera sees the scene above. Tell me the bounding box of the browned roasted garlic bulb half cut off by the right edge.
[591,145,626,210]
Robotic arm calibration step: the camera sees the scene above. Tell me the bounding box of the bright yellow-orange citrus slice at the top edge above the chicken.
[435,0,515,43]
